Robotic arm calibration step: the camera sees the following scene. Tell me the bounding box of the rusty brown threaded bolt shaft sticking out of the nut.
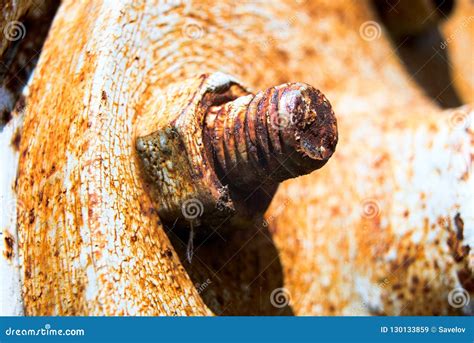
[204,83,337,191]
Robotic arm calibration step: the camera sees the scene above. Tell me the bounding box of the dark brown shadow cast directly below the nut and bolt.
[166,223,293,316]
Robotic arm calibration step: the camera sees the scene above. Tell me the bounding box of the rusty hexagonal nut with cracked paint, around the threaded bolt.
[135,73,256,231]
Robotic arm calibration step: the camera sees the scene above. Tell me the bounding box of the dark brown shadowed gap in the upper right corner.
[374,0,463,108]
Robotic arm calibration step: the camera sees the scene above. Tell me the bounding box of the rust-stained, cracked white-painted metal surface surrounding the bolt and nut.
[12,0,474,315]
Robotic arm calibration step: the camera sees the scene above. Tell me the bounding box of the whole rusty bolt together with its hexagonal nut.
[136,73,337,232]
